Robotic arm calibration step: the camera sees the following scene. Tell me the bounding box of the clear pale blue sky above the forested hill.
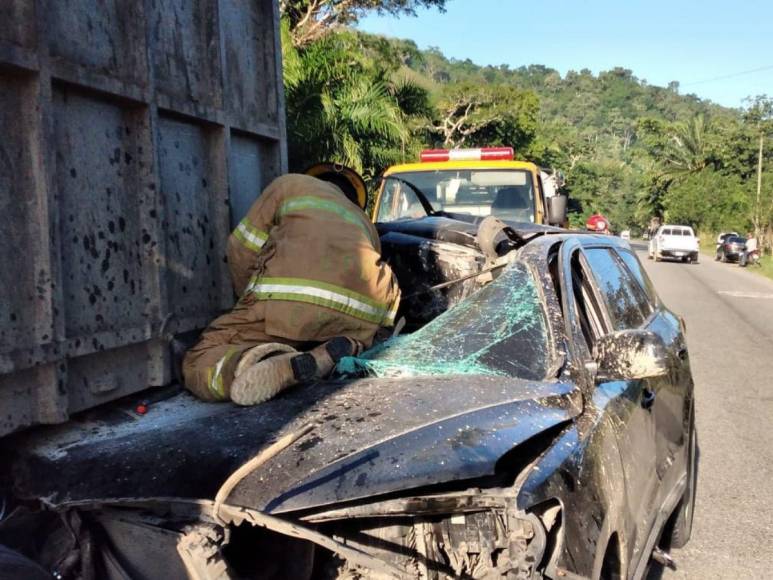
[359,0,773,107]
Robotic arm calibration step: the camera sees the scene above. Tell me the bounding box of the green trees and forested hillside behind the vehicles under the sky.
[281,0,773,247]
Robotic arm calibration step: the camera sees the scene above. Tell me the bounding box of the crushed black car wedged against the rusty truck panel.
[0,215,696,579]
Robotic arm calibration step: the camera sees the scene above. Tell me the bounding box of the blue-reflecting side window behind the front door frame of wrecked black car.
[585,248,650,330]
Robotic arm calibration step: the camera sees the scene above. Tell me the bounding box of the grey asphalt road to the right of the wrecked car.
[634,244,773,579]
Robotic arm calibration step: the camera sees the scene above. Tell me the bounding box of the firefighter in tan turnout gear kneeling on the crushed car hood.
[183,166,400,405]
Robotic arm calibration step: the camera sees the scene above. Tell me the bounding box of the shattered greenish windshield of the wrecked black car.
[338,263,550,380]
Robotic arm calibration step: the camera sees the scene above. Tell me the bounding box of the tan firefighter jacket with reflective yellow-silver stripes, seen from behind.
[223,175,400,343]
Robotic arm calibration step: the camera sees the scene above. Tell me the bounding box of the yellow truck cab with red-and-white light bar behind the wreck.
[372,147,566,225]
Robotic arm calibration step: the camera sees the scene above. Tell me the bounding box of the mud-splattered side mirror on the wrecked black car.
[594,330,668,381]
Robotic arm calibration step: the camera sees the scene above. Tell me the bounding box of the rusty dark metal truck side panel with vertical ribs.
[0,0,286,436]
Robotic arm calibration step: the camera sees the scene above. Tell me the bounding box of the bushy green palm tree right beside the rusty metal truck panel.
[283,26,428,179]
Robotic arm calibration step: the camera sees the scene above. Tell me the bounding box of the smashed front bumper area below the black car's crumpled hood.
[1,489,560,580]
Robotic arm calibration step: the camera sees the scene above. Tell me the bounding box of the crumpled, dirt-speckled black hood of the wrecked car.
[4,376,580,513]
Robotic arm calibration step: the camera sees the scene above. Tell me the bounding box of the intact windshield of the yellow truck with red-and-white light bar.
[376,169,535,222]
